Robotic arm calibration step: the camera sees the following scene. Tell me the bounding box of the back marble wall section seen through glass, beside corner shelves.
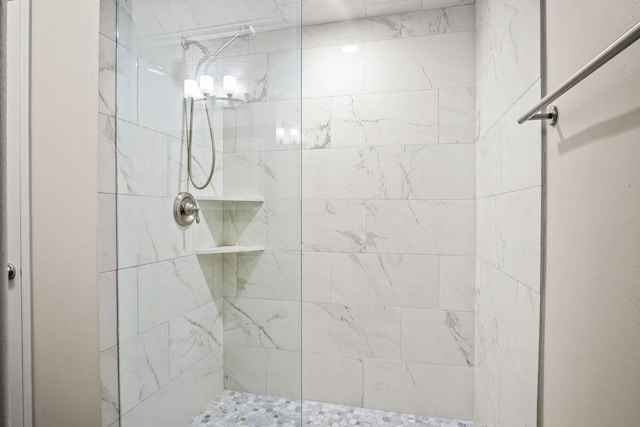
[218,24,301,404]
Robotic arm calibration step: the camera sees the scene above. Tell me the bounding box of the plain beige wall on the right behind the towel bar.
[543,0,640,427]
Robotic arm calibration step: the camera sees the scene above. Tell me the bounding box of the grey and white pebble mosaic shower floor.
[190,391,472,427]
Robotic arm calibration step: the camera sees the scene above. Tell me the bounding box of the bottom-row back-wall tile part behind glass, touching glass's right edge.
[266,350,302,399]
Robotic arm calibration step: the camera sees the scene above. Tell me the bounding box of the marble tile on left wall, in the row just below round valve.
[138,256,213,332]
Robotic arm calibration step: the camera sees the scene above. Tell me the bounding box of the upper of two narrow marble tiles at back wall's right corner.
[439,88,476,144]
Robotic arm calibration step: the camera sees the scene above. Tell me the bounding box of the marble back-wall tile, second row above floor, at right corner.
[402,309,473,367]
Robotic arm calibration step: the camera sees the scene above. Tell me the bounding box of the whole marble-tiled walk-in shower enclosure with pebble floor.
[98,0,542,427]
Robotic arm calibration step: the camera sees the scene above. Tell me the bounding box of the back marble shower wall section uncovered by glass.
[301,5,476,419]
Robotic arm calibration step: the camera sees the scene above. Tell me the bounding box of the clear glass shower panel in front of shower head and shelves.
[115,0,301,427]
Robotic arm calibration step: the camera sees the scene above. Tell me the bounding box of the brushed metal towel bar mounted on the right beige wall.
[518,22,640,126]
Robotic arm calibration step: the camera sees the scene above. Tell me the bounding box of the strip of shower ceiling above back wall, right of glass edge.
[302,0,475,25]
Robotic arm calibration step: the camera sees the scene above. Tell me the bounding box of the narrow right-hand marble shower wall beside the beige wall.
[474,0,542,427]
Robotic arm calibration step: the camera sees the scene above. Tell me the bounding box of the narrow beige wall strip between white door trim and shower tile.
[31,0,100,426]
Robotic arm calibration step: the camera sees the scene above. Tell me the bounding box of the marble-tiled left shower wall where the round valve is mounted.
[98,0,232,427]
